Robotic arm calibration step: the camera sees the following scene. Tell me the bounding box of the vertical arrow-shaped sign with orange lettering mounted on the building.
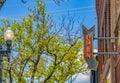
[82,26,98,70]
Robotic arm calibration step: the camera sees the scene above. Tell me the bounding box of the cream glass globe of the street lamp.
[4,27,14,41]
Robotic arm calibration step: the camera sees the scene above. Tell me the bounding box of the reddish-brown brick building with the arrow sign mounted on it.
[96,0,120,83]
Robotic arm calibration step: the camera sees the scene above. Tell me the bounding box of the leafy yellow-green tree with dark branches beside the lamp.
[0,0,86,83]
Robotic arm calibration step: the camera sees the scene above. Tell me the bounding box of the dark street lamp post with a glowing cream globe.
[0,27,14,83]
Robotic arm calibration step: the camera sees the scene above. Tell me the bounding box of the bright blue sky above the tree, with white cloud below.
[0,0,97,83]
